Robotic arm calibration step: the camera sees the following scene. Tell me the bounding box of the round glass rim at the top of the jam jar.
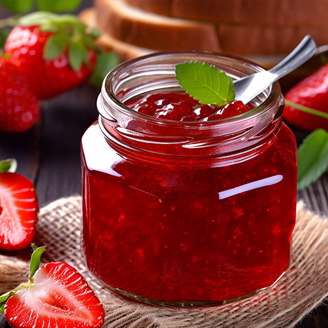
[99,51,281,130]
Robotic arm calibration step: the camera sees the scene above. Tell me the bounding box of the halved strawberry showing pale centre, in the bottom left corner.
[4,262,104,328]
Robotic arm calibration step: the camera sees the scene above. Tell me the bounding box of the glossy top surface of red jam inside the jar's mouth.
[127,93,251,122]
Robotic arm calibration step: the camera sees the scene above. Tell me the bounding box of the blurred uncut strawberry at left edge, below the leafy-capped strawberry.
[0,57,40,132]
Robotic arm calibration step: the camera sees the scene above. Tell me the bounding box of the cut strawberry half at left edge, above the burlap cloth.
[0,172,38,250]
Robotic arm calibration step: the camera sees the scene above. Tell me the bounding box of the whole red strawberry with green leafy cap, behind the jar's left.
[5,12,97,99]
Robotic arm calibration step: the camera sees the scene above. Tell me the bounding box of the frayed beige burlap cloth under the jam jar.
[0,197,328,328]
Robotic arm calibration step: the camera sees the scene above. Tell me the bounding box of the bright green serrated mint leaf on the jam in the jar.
[175,61,235,106]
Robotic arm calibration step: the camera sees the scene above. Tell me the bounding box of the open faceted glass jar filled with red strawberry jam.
[82,52,297,306]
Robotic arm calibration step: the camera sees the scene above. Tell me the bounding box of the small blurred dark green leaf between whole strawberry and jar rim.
[90,52,119,87]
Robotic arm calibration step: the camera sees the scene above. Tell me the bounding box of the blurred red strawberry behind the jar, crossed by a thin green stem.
[283,64,328,131]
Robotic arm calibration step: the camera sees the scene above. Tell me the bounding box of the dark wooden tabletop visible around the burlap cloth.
[0,0,328,328]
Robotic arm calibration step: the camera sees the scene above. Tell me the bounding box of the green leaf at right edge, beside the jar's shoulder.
[297,129,328,190]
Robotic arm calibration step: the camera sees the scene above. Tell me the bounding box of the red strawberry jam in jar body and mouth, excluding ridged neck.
[82,94,296,302]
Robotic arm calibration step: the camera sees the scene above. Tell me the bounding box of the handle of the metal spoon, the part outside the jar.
[269,35,317,81]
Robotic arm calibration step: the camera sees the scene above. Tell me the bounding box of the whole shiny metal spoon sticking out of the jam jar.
[233,35,317,104]
